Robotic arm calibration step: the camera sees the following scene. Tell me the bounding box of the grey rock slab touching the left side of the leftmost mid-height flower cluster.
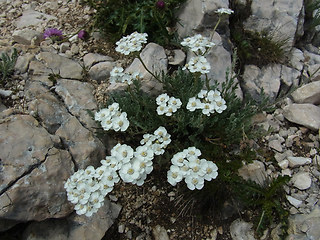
[55,79,97,129]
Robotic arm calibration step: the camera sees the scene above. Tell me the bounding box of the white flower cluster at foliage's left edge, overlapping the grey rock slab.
[94,103,129,132]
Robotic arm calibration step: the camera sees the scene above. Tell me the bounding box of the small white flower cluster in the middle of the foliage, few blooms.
[156,93,182,116]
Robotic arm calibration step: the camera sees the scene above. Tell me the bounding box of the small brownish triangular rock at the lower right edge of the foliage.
[238,160,267,185]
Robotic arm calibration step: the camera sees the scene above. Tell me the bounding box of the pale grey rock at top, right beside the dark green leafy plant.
[176,0,229,38]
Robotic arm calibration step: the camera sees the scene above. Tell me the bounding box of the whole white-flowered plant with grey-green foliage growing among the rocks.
[65,9,290,235]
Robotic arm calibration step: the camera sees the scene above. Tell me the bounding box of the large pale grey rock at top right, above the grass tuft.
[244,0,304,47]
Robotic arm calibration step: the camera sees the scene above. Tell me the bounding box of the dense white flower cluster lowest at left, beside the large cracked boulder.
[64,165,120,217]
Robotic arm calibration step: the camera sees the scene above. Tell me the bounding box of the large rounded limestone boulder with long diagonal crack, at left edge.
[0,115,74,221]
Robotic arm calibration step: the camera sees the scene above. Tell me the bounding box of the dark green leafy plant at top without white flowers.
[82,0,185,45]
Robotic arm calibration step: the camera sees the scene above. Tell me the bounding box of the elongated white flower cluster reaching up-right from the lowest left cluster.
[101,127,171,186]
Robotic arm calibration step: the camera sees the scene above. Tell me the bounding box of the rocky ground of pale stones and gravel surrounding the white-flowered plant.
[0,0,320,240]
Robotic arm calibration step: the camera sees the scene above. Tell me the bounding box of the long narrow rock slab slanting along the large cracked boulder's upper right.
[26,82,105,169]
